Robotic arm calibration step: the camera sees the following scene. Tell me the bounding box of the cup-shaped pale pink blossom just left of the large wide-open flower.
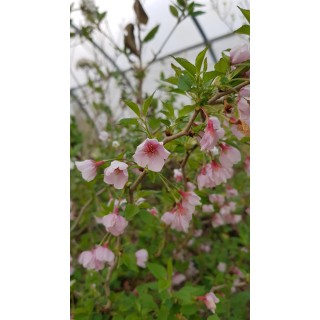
[104,160,128,189]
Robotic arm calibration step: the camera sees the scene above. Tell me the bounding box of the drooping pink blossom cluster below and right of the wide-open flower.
[161,191,201,232]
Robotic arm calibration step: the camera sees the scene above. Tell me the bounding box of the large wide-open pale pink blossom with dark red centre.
[133,139,170,172]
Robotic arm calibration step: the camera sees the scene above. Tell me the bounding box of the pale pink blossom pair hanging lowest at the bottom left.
[78,244,115,271]
